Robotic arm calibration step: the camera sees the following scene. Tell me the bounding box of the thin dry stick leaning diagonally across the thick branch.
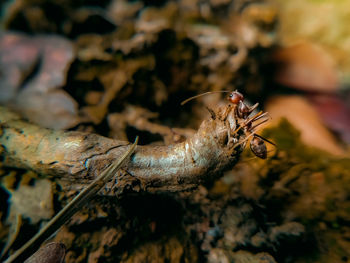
[4,137,138,263]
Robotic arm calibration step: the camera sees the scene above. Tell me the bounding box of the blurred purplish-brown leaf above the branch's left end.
[0,33,79,129]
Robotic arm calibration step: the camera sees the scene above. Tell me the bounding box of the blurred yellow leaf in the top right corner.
[273,0,350,76]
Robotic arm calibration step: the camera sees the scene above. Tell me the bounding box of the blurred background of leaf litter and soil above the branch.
[0,0,350,155]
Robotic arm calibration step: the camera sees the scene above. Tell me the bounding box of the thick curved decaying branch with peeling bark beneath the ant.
[0,105,245,192]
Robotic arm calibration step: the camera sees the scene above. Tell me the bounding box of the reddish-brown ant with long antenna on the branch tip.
[181,90,276,159]
